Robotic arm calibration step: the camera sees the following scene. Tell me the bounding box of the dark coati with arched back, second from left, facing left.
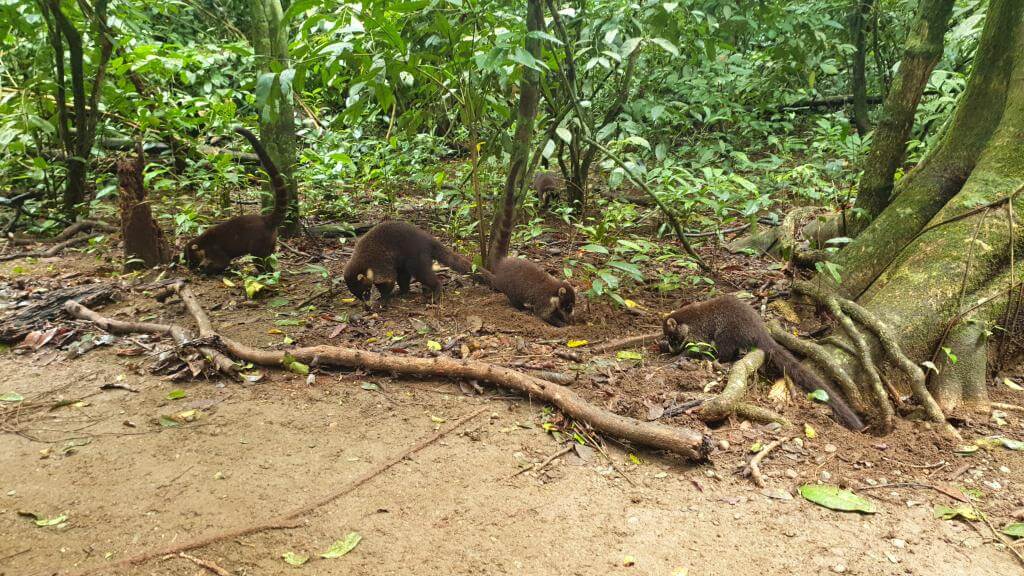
[344,220,473,304]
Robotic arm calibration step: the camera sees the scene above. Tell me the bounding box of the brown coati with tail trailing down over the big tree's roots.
[662,295,864,430]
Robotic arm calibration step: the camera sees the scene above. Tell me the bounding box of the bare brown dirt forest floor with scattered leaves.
[0,203,1024,576]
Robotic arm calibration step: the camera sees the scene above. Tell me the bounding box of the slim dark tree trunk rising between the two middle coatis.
[487,0,544,266]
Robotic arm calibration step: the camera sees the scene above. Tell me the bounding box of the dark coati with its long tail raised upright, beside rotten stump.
[184,128,288,274]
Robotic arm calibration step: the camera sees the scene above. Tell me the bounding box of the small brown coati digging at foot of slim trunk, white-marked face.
[492,258,575,326]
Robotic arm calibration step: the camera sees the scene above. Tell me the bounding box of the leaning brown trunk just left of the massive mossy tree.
[854,0,953,227]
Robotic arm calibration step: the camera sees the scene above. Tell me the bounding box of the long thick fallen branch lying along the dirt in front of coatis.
[72,282,713,461]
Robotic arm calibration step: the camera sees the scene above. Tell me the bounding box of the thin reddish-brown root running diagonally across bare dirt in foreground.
[62,406,488,576]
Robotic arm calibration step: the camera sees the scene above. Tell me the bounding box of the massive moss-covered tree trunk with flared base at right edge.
[818,0,1024,424]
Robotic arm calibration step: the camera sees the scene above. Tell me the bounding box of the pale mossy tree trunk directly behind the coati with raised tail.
[250,0,299,236]
